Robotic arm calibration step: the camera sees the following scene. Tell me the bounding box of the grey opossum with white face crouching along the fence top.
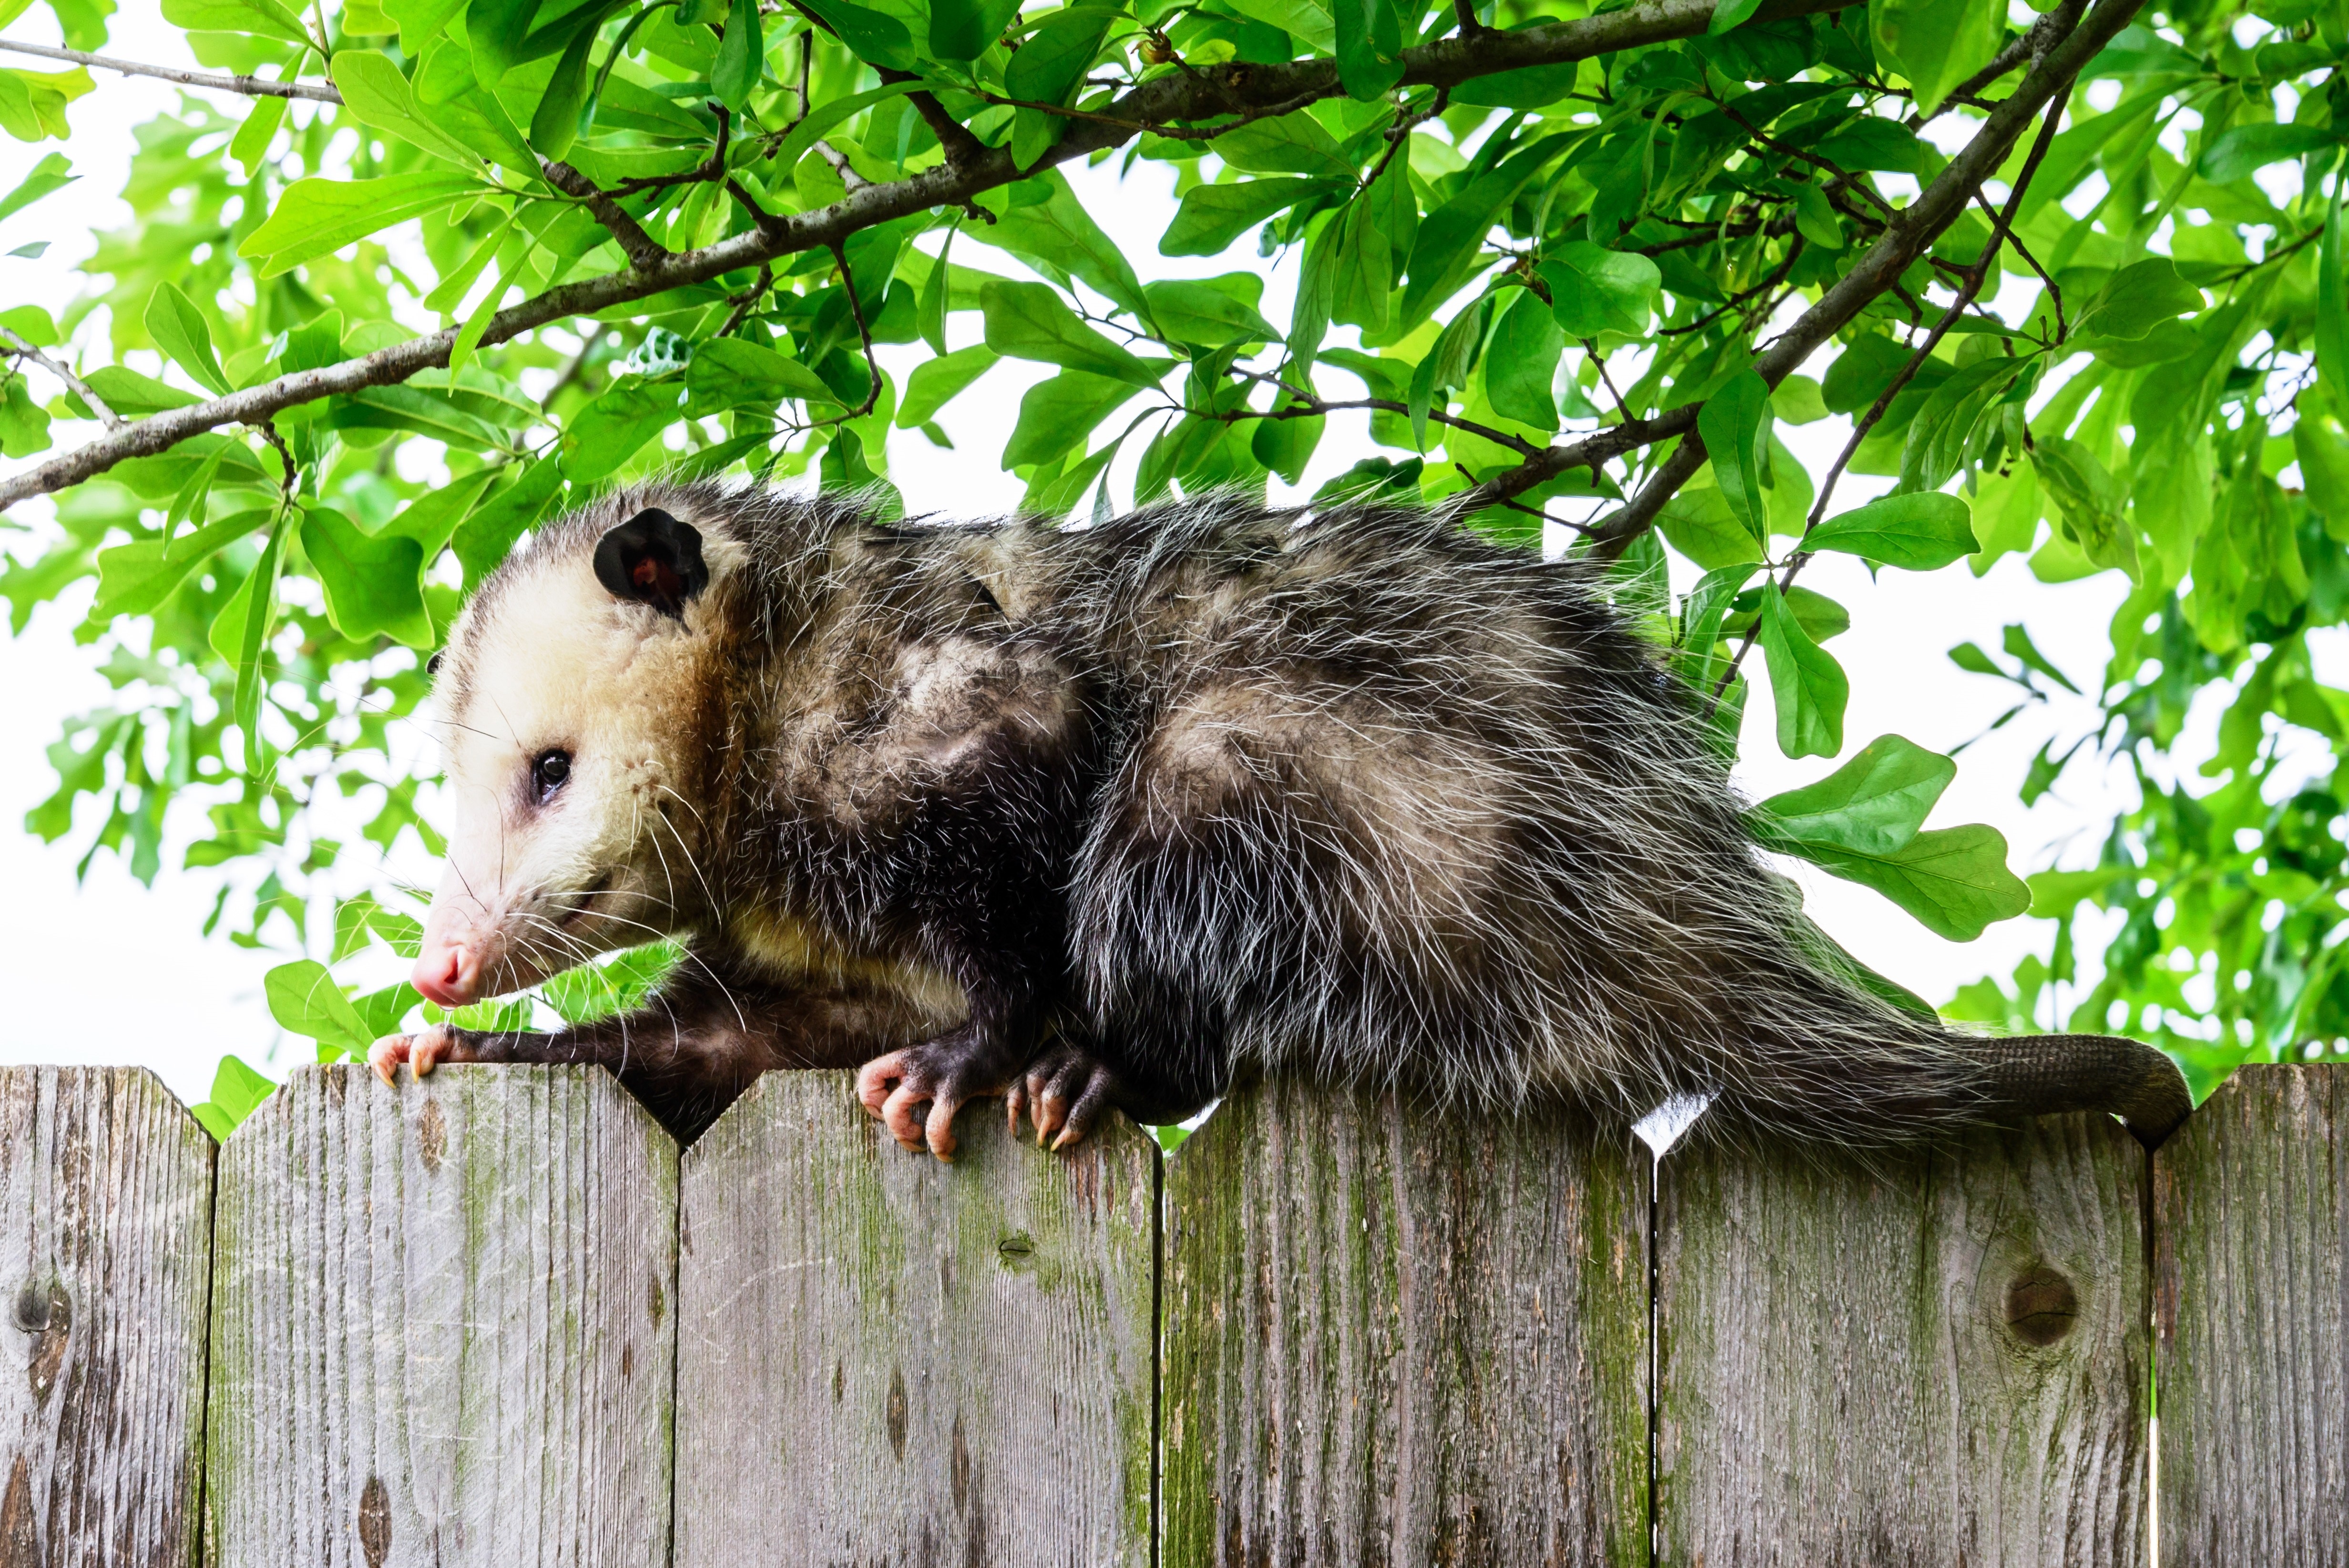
[357,484,2189,1157]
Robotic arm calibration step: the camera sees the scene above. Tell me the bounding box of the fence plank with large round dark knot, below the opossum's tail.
[1656,1115,2147,1568]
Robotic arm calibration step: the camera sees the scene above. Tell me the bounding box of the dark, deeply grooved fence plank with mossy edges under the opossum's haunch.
[1163,1082,1649,1568]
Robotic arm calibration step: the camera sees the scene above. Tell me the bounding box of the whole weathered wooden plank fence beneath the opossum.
[0,1068,2349,1568]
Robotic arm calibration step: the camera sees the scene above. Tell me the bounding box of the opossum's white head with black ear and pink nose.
[416,490,737,1007]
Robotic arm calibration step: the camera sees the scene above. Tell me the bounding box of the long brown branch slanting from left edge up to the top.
[0,0,1851,512]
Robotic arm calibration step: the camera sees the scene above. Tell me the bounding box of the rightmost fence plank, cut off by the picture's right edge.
[2154,1066,2349,1568]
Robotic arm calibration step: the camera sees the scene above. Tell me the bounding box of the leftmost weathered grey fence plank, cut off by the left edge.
[0,1068,214,1568]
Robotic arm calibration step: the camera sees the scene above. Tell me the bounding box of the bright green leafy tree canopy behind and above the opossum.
[0,0,2349,1127]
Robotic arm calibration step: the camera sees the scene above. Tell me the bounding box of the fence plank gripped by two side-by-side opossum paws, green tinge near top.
[676,1073,1158,1568]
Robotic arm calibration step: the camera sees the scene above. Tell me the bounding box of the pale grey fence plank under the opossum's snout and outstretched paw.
[207,1066,676,1568]
